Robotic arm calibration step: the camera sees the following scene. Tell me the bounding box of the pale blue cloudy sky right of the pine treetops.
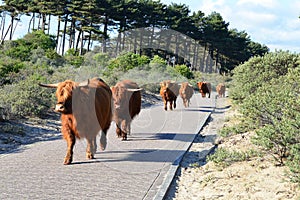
[161,0,300,53]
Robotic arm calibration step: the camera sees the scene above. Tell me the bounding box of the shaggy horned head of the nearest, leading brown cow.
[39,80,89,114]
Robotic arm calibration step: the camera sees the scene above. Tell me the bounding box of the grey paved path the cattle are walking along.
[0,93,215,200]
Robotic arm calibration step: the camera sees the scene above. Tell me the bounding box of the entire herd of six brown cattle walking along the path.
[39,78,225,165]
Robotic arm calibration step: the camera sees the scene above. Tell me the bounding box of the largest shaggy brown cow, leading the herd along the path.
[39,78,112,165]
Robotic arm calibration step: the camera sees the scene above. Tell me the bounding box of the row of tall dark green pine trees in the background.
[0,0,268,71]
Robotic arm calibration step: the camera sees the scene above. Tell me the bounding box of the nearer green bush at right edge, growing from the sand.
[241,67,300,164]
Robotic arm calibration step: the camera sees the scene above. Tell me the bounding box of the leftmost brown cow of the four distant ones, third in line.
[160,80,179,110]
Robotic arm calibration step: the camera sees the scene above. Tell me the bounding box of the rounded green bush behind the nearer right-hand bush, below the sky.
[230,51,300,103]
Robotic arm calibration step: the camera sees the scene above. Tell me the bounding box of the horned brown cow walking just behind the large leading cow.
[111,80,142,140]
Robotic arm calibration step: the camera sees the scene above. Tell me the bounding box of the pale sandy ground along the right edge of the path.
[165,99,300,200]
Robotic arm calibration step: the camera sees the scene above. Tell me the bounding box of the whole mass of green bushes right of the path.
[230,52,300,182]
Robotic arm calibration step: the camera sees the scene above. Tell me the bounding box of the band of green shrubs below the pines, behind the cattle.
[0,31,223,121]
